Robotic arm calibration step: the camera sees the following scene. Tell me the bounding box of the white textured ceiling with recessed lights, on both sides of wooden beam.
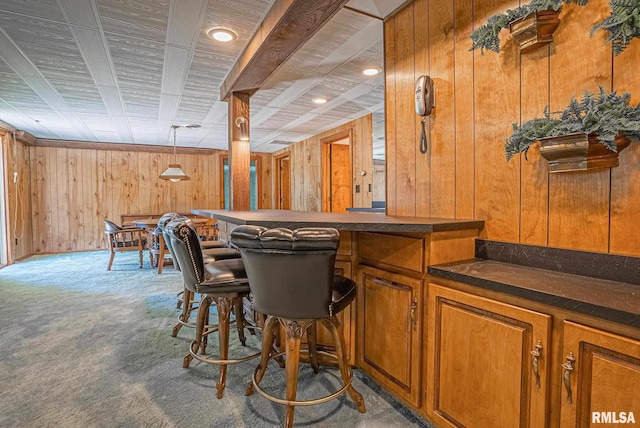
[0,0,396,158]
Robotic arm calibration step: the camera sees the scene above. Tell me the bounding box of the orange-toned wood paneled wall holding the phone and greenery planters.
[385,0,640,255]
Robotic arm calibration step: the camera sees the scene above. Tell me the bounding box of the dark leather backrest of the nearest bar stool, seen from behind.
[231,226,340,319]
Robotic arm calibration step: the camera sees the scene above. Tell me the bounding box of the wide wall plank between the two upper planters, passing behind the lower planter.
[549,0,612,251]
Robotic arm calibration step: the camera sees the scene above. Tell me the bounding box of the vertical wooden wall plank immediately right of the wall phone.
[418,1,456,218]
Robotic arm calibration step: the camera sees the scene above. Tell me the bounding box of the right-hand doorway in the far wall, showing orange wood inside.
[321,129,353,213]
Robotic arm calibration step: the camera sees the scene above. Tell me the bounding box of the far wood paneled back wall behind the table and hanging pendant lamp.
[4,144,272,260]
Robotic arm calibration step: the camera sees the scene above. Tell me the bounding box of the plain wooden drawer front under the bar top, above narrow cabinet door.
[358,232,424,272]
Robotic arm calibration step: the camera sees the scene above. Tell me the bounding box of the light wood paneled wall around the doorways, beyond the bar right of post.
[271,114,373,211]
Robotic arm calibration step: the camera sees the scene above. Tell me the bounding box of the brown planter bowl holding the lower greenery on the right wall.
[540,132,631,172]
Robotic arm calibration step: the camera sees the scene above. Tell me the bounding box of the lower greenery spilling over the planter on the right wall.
[504,87,640,160]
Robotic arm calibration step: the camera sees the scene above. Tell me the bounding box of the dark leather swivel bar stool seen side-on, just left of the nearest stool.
[165,219,260,398]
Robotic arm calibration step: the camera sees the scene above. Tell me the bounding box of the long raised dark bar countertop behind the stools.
[191,209,484,233]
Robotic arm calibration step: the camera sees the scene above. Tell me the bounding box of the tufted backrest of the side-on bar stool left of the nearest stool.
[165,218,205,292]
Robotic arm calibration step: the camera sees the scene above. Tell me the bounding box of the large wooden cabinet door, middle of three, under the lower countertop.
[426,284,551,428]
